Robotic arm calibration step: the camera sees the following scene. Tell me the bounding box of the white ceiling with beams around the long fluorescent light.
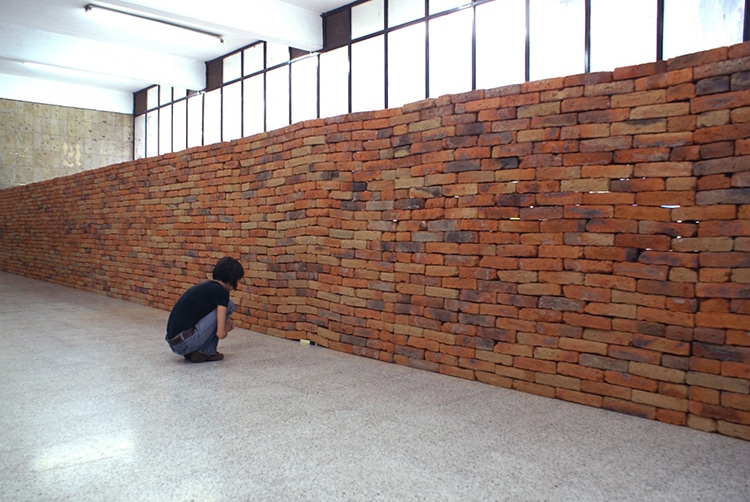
[0,0,352,113]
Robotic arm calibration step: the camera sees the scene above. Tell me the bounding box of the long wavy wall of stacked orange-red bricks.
[0,44,750,439]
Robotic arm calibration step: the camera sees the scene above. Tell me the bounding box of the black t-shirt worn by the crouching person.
[167,281,229,338]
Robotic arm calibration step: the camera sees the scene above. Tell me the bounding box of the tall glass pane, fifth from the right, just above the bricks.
[429,9,474,98]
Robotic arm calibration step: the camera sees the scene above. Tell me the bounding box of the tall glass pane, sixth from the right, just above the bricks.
[388,23,425,108]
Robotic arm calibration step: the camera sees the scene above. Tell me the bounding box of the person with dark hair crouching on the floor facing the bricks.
[166,256,245,363]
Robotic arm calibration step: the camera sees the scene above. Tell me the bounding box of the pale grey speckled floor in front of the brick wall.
[0,273,750,502]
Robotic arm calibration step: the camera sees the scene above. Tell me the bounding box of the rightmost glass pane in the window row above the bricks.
[664,0,745,59]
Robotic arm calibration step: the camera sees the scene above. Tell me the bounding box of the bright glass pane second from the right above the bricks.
[591,0,656,71]
